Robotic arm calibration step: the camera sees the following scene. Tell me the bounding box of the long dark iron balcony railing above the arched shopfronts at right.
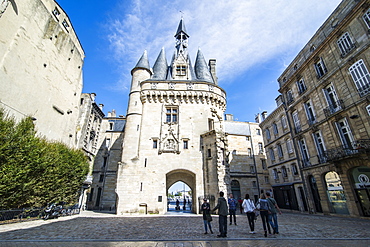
[324,139,370,162]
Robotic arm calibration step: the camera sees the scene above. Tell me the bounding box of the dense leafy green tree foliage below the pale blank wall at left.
[0,109,88,209]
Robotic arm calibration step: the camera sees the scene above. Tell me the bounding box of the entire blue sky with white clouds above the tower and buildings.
[56,0,340,122]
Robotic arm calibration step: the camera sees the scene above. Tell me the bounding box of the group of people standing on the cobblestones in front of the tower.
[201,191,281,238]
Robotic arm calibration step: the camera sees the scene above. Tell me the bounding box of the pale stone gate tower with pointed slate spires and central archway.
[116,20,227,214]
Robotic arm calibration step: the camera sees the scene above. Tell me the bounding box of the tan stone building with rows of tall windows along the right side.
[264,0,370,216]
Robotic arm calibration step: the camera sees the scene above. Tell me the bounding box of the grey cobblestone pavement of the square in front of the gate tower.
[0,211,370,247]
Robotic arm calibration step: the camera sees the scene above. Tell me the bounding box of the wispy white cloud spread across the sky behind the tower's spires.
[107,0,340,91]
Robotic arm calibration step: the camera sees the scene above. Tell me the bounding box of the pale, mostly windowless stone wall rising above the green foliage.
[0,0,85,147]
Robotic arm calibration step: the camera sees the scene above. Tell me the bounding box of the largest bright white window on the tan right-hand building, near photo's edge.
[349,59,370,97]
